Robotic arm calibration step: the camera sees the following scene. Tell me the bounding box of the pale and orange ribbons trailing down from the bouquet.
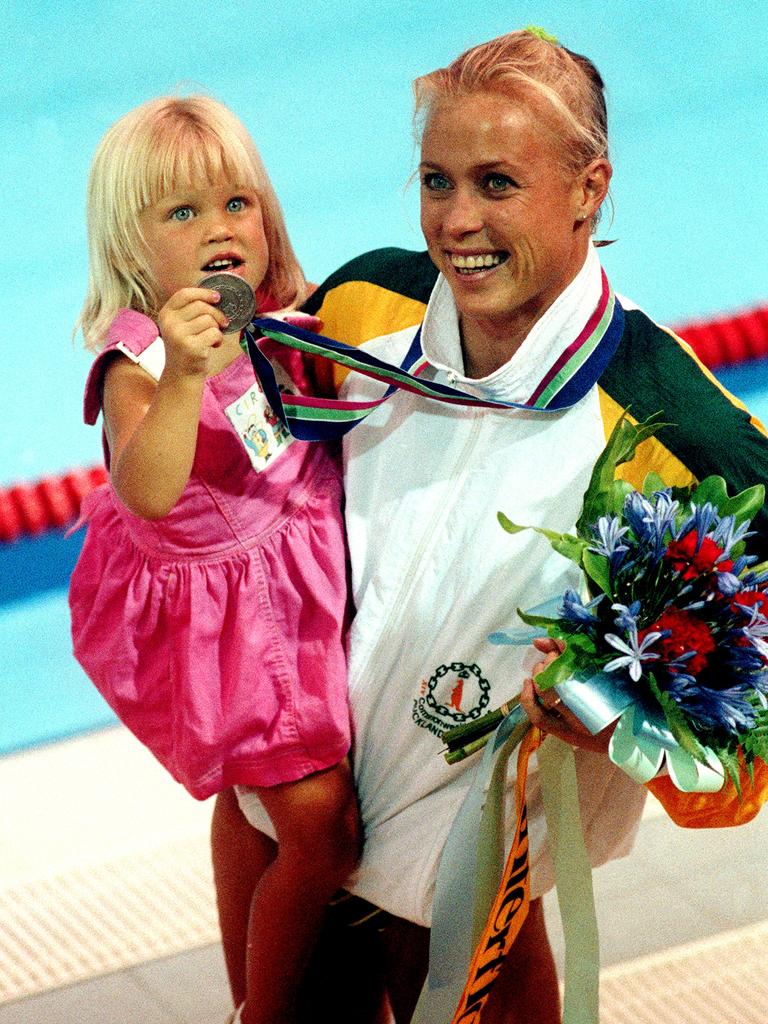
[412,705,600,1024]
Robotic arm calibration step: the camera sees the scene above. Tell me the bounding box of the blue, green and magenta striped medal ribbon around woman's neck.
[244,271,624,440]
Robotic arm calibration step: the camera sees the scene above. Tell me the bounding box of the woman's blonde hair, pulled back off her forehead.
[414,29,608,171]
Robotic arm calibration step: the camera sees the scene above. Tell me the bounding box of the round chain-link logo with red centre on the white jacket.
[413,662,490,736]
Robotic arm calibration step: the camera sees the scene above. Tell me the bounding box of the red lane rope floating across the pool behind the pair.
[0,305,768,543]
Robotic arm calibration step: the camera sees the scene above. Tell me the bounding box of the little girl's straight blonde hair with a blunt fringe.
[77,95,308,350]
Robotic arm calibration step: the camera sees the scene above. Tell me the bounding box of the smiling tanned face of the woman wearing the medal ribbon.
[420,93,610,350]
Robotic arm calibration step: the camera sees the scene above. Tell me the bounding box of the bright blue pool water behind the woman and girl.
[0,0,768,753]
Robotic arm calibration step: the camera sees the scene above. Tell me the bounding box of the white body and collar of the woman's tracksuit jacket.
[344,250,645,925]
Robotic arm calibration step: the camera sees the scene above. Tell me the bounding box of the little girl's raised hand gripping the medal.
[158,288,229,378]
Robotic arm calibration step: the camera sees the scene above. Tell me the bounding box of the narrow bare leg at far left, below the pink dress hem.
[211,790,278,1007]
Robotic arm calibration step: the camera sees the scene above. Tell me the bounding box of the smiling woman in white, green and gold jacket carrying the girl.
[215,31,768,1024]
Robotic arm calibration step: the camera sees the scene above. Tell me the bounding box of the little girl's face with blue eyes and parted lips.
[140,180,269,306]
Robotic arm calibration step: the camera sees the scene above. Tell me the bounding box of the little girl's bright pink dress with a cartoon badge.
[70,310,350,800]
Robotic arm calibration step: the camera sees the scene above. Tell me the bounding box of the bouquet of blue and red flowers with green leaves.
[443,415,768,790]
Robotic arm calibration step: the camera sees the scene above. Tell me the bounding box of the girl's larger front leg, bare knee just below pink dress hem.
[243,760,360,1024]
